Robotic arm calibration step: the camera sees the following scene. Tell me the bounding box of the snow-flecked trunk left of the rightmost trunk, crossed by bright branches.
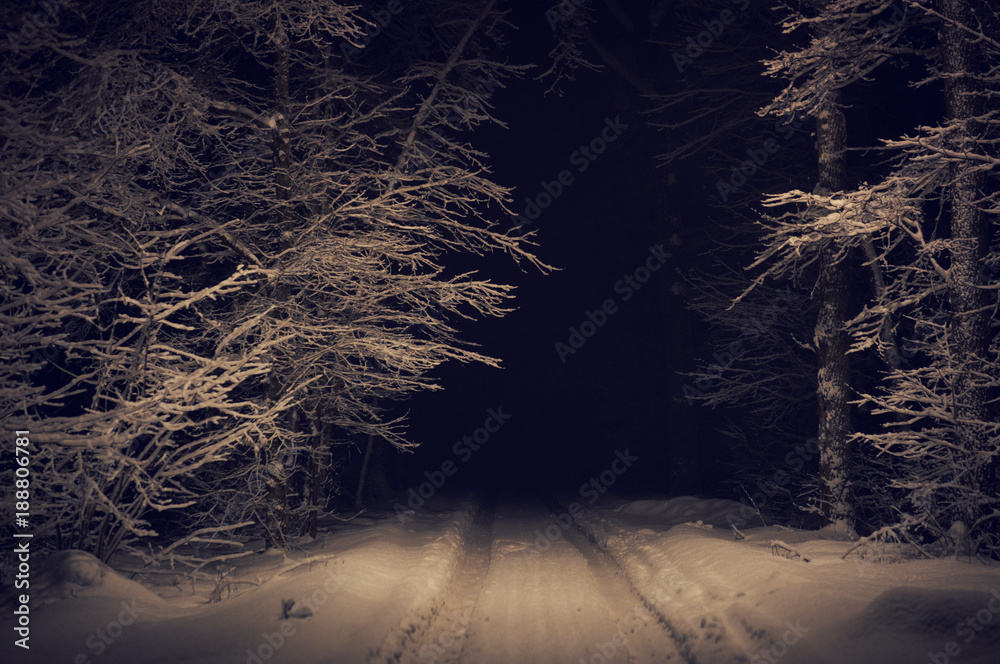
[814,85,853,525]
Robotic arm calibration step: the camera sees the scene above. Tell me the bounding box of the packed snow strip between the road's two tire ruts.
[450,502,684,664]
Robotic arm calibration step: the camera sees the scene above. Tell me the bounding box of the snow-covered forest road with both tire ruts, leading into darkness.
[380,503,688,664]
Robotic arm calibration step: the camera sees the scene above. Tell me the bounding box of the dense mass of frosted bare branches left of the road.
[2,0,544,558]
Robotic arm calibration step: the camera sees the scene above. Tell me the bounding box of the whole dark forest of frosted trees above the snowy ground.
[0,0,1000,585]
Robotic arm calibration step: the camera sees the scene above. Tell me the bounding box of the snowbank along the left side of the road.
[0,503,472,664]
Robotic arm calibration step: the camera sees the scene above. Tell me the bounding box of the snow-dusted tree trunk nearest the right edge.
[940,0,997,522]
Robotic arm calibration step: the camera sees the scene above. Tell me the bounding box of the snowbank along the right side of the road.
[579,497,1000,664]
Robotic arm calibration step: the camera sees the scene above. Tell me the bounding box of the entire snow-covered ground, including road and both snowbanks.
[0,498,1000,664]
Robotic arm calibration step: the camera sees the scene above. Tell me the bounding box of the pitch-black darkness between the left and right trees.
[370,0,942,506]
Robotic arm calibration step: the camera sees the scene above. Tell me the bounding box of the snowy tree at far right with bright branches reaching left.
[759,2,998,552]
